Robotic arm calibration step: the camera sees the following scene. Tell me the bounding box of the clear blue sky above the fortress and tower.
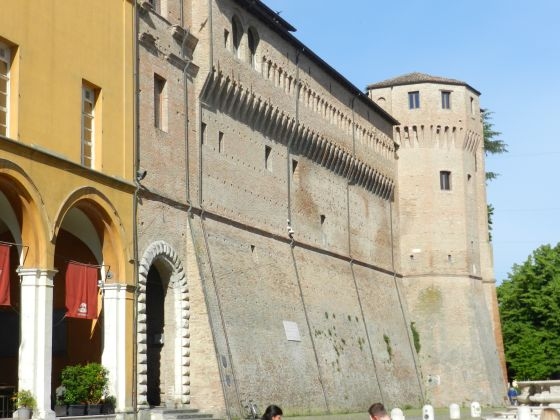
[264,0,560,282]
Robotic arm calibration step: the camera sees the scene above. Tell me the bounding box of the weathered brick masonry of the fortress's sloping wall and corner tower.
[138,0,503,416]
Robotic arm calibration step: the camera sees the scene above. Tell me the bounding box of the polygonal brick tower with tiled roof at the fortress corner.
[368,73,504,404]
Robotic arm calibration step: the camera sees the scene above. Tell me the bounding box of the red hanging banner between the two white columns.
[66,261,98,319]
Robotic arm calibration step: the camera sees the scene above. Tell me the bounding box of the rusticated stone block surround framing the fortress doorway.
[137,241,190,405]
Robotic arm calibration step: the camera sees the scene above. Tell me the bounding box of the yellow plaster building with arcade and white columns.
[0,0,136,418]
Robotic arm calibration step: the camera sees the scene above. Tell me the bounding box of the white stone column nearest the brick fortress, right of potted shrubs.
[102,283,132,411]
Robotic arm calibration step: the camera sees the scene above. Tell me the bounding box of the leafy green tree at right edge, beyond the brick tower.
[497,243,560,380]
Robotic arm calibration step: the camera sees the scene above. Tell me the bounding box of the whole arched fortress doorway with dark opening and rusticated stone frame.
[138,241,190,407]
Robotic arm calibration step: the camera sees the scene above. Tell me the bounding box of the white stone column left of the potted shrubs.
[18,268,57,420]
